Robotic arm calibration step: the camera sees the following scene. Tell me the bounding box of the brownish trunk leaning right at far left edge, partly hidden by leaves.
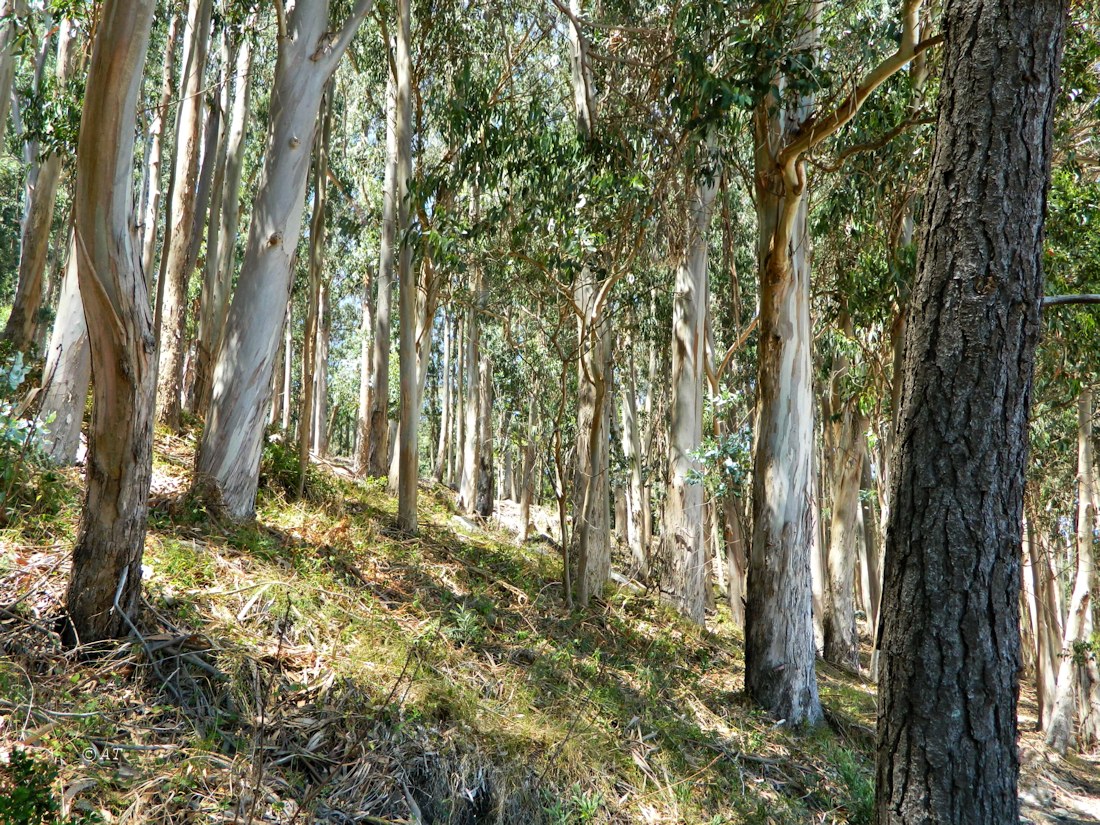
[2,20,81,352]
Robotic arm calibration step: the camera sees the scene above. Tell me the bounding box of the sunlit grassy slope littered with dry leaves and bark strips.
[0,433,1100,825]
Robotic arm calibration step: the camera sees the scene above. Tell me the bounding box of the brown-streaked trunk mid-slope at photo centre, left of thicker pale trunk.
[572,267,612,607]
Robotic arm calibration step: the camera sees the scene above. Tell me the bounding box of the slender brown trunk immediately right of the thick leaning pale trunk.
[298,93,332,498]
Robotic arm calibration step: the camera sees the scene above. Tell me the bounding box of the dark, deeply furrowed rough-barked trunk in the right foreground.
[876,0,1066,825]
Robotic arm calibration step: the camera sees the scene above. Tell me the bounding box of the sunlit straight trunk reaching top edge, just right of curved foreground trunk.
[156,0,213,430]
